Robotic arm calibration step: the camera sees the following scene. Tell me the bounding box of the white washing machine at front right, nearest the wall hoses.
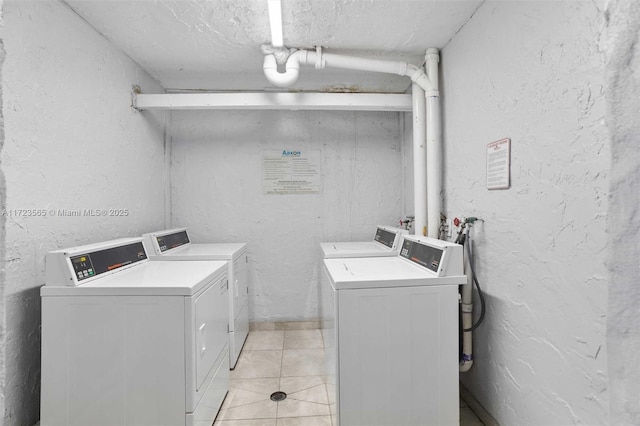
[321,235,467,426]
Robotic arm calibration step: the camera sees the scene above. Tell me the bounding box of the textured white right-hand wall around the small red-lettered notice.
[442,1,608,425]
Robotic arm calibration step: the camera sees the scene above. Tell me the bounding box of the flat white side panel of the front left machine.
[41,296,185,426]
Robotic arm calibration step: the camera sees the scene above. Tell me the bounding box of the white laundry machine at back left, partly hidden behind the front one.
[142,228,249,369]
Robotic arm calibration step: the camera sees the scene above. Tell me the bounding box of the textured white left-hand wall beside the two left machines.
[1,0,165,425]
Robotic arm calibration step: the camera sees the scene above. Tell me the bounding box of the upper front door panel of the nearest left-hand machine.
[195,275,229,391]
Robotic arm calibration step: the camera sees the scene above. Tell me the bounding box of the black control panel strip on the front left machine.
[69,242,147,281]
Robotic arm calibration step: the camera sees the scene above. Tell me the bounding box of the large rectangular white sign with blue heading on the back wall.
[262,149,322,195]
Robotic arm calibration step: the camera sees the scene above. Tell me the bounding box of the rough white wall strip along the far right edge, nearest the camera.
[606,0,640,425]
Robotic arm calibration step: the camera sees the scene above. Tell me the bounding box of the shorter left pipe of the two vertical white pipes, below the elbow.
[411,83,427,235]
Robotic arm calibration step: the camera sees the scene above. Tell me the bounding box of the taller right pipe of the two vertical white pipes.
[425,48,442,238]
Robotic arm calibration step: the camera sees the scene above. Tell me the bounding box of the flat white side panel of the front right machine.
[337,286,459,426]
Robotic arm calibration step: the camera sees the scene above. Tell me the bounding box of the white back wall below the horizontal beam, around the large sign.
[171,111,403,321]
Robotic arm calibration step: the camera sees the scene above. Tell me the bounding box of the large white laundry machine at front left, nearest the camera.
[40,238,229,426]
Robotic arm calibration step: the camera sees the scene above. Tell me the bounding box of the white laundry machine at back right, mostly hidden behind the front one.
[320,226,407,259]
